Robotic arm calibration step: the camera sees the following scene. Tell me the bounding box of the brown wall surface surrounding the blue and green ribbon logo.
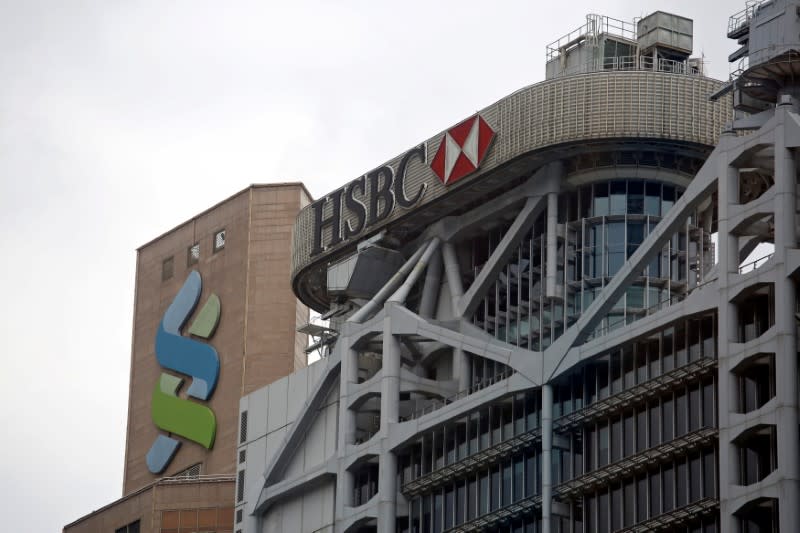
[123,184,309,497]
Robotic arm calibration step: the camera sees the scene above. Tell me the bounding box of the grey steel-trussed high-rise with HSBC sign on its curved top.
[241,5,800,533]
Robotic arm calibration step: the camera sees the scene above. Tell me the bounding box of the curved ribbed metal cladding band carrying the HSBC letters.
[292,71,730,310]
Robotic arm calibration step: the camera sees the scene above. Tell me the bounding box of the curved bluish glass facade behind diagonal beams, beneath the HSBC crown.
[470,178,713,350]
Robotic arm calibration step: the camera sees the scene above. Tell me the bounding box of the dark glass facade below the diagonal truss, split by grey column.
[398,313,718,533]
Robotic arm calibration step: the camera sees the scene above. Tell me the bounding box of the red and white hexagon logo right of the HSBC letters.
[431,115,494,185]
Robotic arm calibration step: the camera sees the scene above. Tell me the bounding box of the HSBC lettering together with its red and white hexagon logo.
[310,115,495,257]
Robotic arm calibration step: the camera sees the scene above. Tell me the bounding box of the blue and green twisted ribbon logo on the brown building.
[146,271,220,474]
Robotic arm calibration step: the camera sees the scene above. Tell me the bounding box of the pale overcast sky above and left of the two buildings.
[0,0,744,531]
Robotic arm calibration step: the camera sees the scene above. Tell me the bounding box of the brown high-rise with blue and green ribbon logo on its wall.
[64,183,310,533]
